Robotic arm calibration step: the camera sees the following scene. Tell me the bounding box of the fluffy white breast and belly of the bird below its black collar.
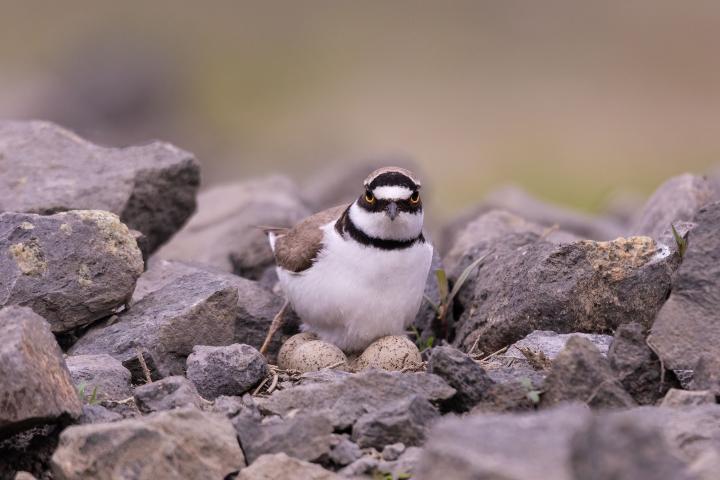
[278,222,433,351]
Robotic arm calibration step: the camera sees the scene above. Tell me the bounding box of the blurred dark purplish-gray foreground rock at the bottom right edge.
[570,415,694,480]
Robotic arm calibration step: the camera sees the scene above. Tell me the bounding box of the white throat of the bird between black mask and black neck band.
[349,202,423,240]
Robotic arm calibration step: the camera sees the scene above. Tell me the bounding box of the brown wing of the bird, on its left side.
[275,205,348,273]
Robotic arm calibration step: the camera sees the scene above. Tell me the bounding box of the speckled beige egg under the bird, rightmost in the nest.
[352,335,422,372]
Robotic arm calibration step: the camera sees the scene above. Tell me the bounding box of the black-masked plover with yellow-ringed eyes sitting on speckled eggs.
[268,167,433,352]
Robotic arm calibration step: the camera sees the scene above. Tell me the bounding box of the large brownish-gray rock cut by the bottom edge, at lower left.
[52,408,245,480]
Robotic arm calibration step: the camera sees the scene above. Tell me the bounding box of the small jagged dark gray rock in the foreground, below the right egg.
[352,395,440,450]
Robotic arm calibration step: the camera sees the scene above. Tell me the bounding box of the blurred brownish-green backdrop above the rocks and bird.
[0,0,720,213]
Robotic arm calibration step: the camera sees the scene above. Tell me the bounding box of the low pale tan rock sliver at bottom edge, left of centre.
[237,453,343,480]
